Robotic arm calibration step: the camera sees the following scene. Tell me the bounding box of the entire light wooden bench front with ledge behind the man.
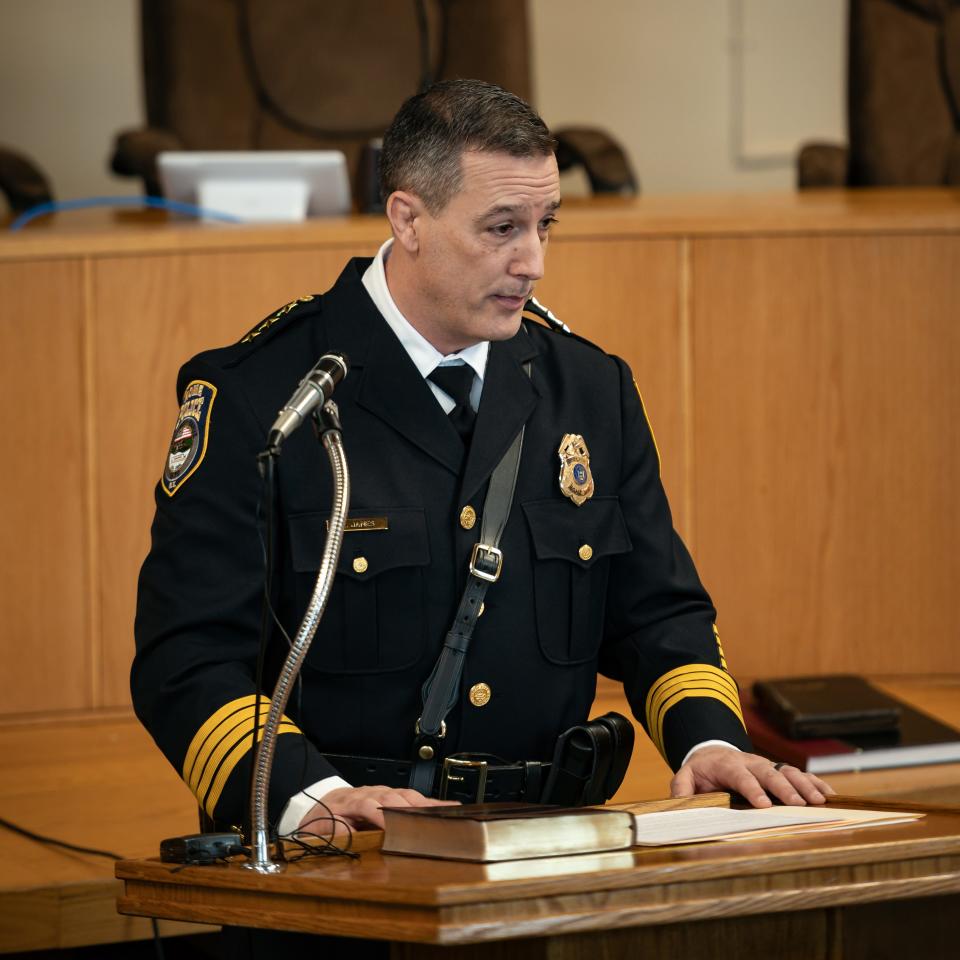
[0,190,960,720]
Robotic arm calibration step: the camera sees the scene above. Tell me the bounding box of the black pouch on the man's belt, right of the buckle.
[541,712,634,807]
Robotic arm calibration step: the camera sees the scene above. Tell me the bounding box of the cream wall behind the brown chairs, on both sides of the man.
[0,0,846,212]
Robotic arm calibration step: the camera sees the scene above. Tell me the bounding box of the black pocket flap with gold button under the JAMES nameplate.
[288,507,430,580]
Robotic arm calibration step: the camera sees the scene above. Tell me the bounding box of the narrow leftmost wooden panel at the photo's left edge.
[0,260,92,716]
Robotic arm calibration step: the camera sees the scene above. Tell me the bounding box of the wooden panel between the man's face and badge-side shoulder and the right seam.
[536,238,690,537]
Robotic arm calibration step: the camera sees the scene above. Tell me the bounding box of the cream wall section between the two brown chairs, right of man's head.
[530,0,847,193]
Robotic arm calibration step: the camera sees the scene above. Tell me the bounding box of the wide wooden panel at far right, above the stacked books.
[693,235,960,676]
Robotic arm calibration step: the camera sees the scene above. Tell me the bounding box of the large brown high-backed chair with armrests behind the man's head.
[112,0,636,209]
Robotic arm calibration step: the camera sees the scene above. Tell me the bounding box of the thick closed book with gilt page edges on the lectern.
[383,803,633,863]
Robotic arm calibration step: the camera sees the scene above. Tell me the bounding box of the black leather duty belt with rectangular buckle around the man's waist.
[325,753,550,803]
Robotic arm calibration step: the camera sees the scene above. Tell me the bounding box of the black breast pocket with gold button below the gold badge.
[521,497,631,664]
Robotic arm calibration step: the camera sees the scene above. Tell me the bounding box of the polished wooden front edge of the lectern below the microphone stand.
[117,811,960,944]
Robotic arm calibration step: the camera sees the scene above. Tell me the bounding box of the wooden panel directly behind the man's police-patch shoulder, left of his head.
[94,240,376,705]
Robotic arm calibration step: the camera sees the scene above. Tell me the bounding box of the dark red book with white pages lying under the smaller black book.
[743,701,960,773]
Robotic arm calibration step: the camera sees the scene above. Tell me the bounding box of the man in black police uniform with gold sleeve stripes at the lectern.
[132,81,829,864]
